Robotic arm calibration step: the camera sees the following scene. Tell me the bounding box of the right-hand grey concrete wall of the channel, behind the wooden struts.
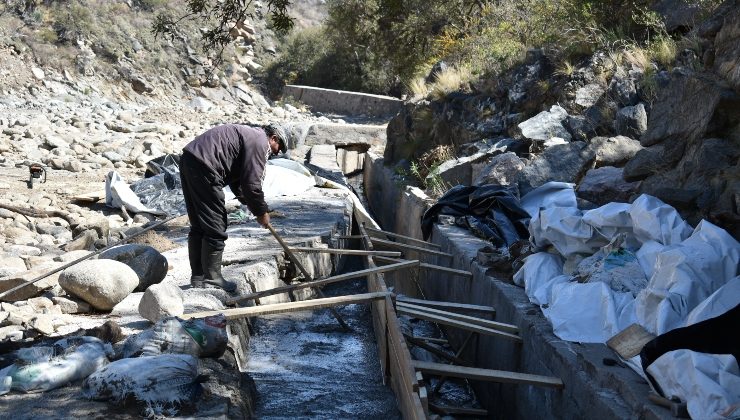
[364,154,671,419]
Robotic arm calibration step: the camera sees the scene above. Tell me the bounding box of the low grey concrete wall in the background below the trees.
[283,85,403,117]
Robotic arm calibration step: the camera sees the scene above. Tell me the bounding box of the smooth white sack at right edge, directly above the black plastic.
[635,220,740,335]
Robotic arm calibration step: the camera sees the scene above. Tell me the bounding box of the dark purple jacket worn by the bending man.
[183,124,271,216]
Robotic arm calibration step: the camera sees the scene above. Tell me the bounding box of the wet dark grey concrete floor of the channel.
[247,262,401,419]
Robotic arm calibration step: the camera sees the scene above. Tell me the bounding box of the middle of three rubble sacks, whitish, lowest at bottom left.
[82,354,206,417]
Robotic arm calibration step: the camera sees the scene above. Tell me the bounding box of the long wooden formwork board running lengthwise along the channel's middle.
[360,226,428,419]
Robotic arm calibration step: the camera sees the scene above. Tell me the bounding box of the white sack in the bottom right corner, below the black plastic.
[647,350,740,420]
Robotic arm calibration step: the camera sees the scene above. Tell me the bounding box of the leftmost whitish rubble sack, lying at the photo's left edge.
[0,336,113,395]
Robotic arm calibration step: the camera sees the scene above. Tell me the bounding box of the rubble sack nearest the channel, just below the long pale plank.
[122,314,228,358]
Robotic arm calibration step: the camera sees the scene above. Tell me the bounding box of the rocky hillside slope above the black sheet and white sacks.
[385,0,740,238]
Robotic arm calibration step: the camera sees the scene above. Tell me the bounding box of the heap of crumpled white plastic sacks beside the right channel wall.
[514,182,740,419]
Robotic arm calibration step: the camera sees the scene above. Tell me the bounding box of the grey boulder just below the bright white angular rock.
[517,142,595,195]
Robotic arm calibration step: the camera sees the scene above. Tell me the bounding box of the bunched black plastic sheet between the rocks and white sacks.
[421,185,529,247]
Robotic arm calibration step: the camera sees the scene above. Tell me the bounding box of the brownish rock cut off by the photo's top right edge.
[714,2,740,92]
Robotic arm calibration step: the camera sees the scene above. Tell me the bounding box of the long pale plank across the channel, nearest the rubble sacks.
[180,292,390,319]
